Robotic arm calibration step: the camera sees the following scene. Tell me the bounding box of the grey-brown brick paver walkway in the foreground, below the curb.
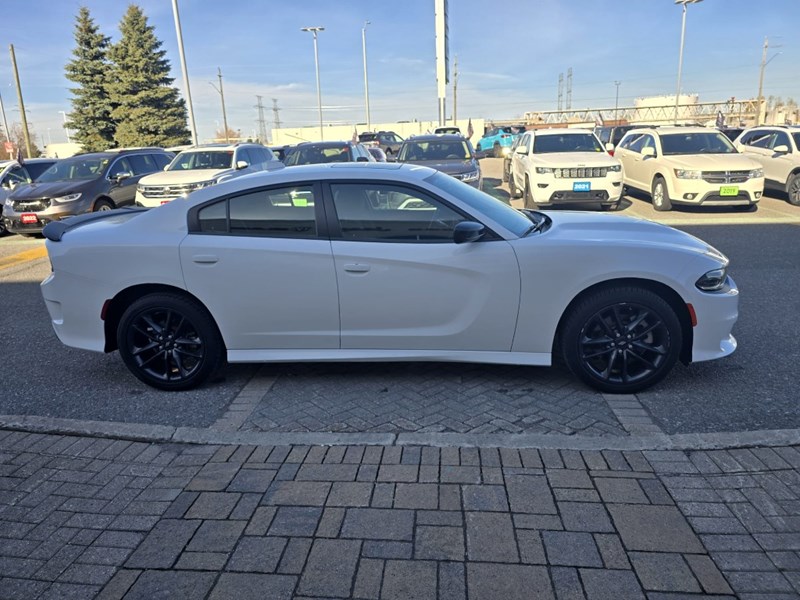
[0,431,800,600]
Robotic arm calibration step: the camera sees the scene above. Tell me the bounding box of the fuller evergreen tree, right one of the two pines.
[108,4,189,147]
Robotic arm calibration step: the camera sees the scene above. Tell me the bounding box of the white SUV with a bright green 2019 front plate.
[614,127,764,211]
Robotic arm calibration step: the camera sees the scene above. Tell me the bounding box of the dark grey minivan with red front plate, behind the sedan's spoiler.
[3,148,175,235]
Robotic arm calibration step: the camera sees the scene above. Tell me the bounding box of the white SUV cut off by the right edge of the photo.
[734,126,800,206]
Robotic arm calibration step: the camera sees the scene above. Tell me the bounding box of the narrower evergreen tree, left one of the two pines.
[65,6,115,152]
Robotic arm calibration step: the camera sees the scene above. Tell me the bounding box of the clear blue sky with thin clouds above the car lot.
[0,0,800,143]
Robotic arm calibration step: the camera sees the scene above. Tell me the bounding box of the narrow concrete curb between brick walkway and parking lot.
[0,415,800,450]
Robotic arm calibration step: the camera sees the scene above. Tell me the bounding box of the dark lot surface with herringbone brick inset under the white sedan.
[0,159,800,436]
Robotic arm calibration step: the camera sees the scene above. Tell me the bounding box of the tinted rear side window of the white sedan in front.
[197,185,317,239]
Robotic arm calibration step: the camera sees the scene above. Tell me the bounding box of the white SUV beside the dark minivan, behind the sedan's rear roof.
[136,143,283,207]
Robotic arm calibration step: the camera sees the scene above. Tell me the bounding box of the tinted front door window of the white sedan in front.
[331,183,465,243]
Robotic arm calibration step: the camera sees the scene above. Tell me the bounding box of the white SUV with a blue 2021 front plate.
[508,129,622,210]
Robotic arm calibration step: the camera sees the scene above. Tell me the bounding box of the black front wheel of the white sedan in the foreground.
[560,286,683,394]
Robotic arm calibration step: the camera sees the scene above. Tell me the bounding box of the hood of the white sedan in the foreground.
[545,211,727,261]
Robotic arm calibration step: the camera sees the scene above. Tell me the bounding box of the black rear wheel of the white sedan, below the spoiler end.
[117,293,225,391]
